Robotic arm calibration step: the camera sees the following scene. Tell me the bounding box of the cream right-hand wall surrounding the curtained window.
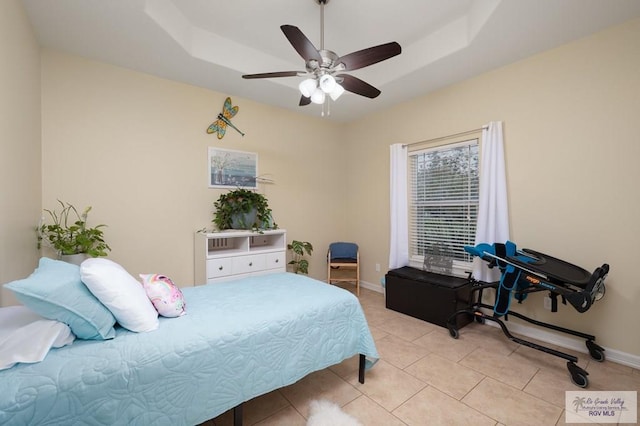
[347,20,640,356]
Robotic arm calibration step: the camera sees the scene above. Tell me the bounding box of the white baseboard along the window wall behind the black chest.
[360,280,640,370]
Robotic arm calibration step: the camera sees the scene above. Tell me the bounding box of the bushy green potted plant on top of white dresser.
[213,188,278,231]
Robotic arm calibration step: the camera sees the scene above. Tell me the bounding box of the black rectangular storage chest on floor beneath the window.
[385,266,472,328]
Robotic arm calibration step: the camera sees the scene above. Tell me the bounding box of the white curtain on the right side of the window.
[473,121,509,282]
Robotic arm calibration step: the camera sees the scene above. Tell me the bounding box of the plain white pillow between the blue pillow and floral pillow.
[80,258,159,332]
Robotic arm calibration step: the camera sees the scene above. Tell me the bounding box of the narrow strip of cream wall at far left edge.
[0,0,41,306]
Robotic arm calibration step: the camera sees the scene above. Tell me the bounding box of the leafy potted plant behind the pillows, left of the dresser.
[37,200,111,262]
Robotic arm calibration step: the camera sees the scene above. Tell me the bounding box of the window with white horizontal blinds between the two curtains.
[409,139,478,274]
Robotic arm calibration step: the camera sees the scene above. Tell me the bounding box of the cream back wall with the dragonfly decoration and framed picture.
[42,51,347,285]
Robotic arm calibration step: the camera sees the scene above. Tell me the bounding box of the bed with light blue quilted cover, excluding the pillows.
[0,273,378,425]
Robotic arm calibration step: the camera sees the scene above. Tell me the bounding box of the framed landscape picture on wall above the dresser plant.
[209,147,258,189]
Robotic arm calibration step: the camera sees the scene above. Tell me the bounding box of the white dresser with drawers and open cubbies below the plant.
[194,229,287,285]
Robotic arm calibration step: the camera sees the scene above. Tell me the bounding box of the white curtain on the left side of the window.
[389,144,409,269]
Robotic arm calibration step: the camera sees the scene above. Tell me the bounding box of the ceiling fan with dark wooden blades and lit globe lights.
[242,0,402,106]
